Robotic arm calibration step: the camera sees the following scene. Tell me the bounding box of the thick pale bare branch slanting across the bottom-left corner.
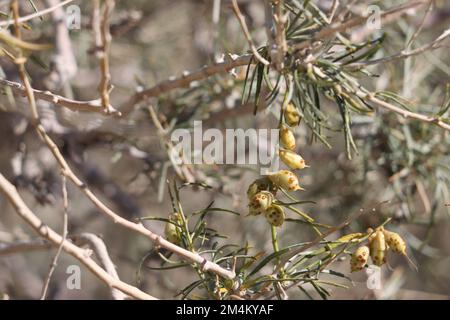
[0,173,155,300]
